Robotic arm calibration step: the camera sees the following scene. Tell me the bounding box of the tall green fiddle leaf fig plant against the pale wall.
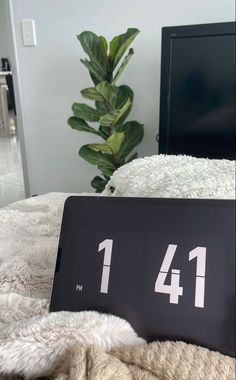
[68,28,143,192]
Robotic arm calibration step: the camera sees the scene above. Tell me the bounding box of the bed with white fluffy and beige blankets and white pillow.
[0,155,235,380]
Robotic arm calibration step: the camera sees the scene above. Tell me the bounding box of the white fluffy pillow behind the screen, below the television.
[102,155,235,199]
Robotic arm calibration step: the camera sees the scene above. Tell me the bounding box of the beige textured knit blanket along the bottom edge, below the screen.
[2,341,235,380]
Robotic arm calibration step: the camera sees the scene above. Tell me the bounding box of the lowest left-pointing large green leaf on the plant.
[79,145,115,169]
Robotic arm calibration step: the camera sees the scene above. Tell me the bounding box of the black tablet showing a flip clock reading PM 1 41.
[50,197,235,356]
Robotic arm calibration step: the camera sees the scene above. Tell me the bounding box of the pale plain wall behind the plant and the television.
[10,0,235,194]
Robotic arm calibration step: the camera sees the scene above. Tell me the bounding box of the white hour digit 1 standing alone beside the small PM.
[98,239,113,293]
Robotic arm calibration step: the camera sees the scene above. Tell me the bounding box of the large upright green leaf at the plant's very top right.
[109,28,139,70]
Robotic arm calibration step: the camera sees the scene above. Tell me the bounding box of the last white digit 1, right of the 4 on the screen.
[189,247,206,307]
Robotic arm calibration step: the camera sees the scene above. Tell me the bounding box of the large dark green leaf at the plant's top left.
[77,31,107,76]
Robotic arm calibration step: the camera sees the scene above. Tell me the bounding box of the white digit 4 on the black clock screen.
[155,244,183,303]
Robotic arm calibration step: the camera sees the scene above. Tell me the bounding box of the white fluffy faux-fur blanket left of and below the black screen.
[0,193,143,378]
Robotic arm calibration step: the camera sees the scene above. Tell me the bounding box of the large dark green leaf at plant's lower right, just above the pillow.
[116,121,143,161]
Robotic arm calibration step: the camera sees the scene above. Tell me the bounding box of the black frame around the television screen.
[156,21,236,158]
